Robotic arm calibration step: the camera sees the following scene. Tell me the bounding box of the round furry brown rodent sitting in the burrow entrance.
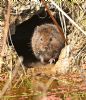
[31,24,65,63]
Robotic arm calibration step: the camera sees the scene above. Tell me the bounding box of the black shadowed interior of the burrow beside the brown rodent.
[11,9,60,66]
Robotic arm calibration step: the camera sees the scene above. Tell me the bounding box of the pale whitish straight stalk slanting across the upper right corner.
[50,0,86,35]
